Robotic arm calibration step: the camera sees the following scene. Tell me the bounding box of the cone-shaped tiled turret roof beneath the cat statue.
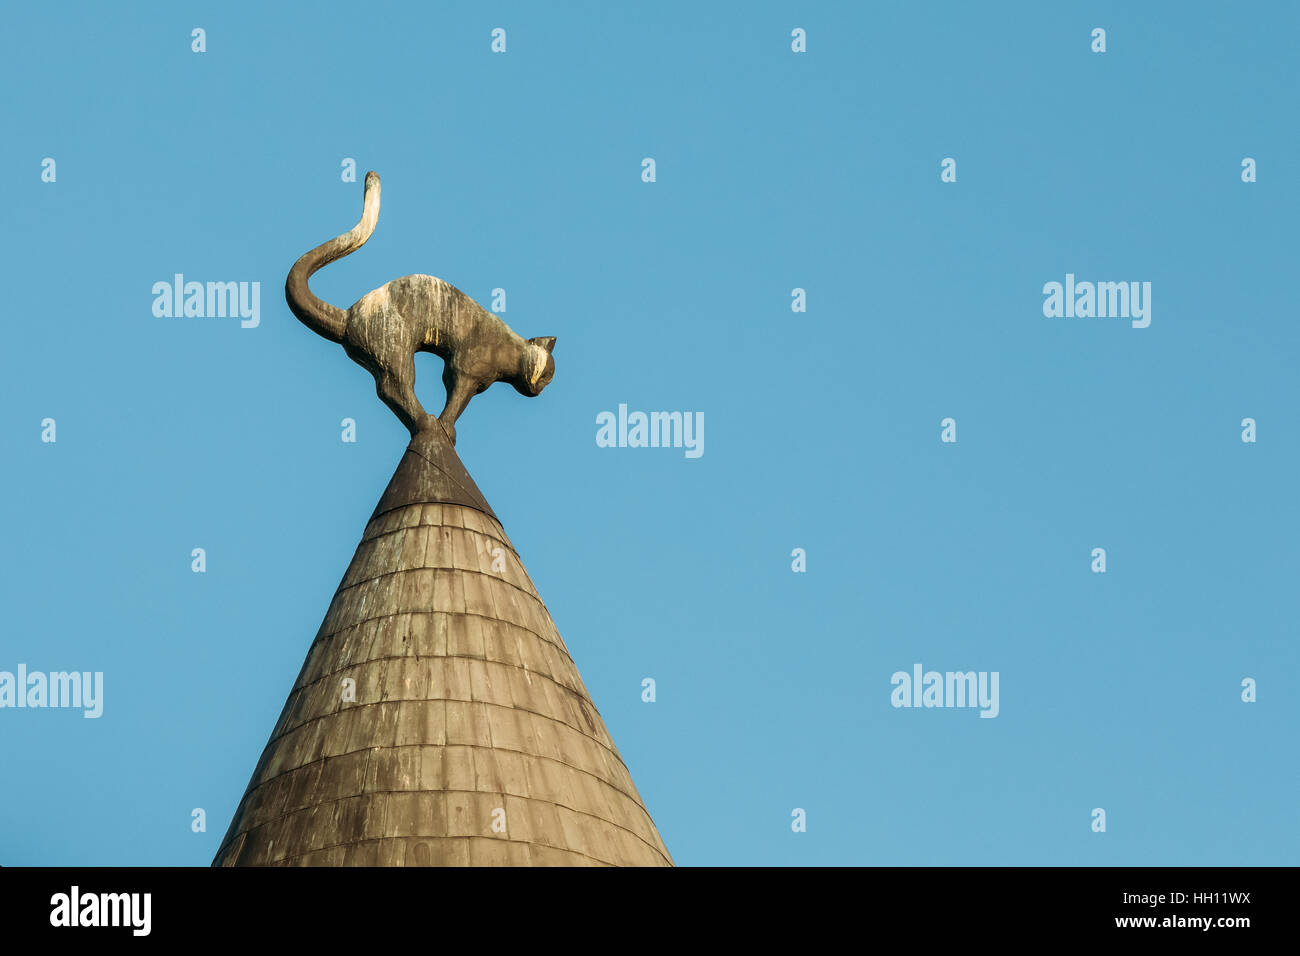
[213,429,672,866]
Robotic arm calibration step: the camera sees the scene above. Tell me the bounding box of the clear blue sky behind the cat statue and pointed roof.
[0,0,1300,865]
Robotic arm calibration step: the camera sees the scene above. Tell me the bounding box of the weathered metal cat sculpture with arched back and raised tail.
[285,172,555,444]
